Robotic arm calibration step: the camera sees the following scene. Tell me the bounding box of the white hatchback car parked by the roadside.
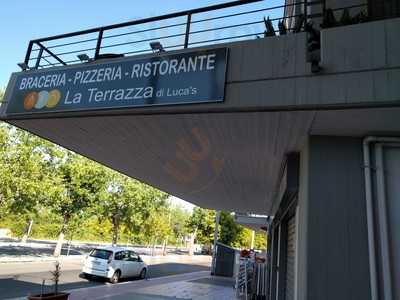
[82,247,147,283]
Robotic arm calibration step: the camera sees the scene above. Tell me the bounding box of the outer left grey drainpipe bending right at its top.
[363,136,400,300]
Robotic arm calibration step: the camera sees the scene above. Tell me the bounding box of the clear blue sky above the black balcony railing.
[0,0,283,88]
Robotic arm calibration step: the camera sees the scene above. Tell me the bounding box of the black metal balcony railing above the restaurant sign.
[24,0,366,69]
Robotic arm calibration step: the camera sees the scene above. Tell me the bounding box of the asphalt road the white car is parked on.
[0,255,211,299]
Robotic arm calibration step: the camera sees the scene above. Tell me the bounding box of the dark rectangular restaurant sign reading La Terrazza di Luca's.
[5,48,228,117]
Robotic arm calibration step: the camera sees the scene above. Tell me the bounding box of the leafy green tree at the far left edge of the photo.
[0,123,62,241]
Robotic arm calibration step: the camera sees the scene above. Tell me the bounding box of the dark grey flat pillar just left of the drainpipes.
[297,136,371,300]
